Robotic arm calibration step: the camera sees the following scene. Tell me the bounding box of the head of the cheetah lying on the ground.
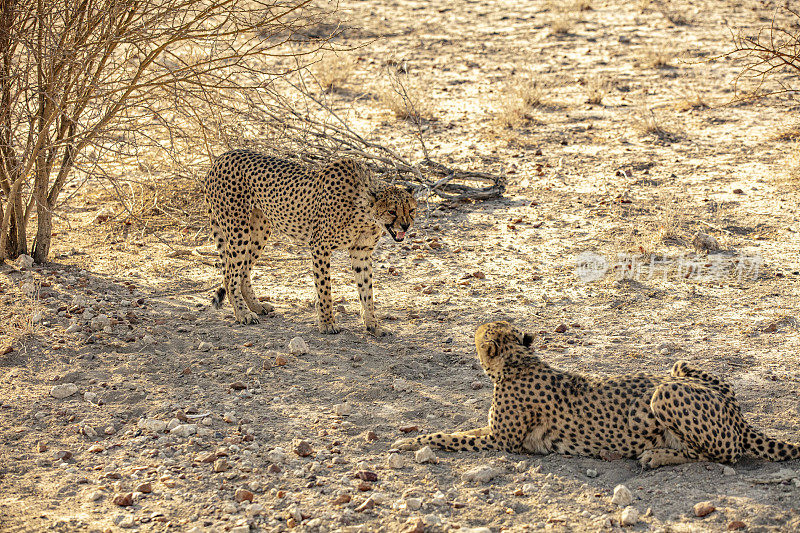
[475,321,533,379]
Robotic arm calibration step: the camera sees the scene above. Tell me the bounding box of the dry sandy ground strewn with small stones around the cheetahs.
[0,0,800,532]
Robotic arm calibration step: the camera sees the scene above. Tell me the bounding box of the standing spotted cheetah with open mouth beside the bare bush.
[202,150,416,336]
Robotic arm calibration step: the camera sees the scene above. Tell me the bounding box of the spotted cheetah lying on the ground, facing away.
[393,322,800,468]
